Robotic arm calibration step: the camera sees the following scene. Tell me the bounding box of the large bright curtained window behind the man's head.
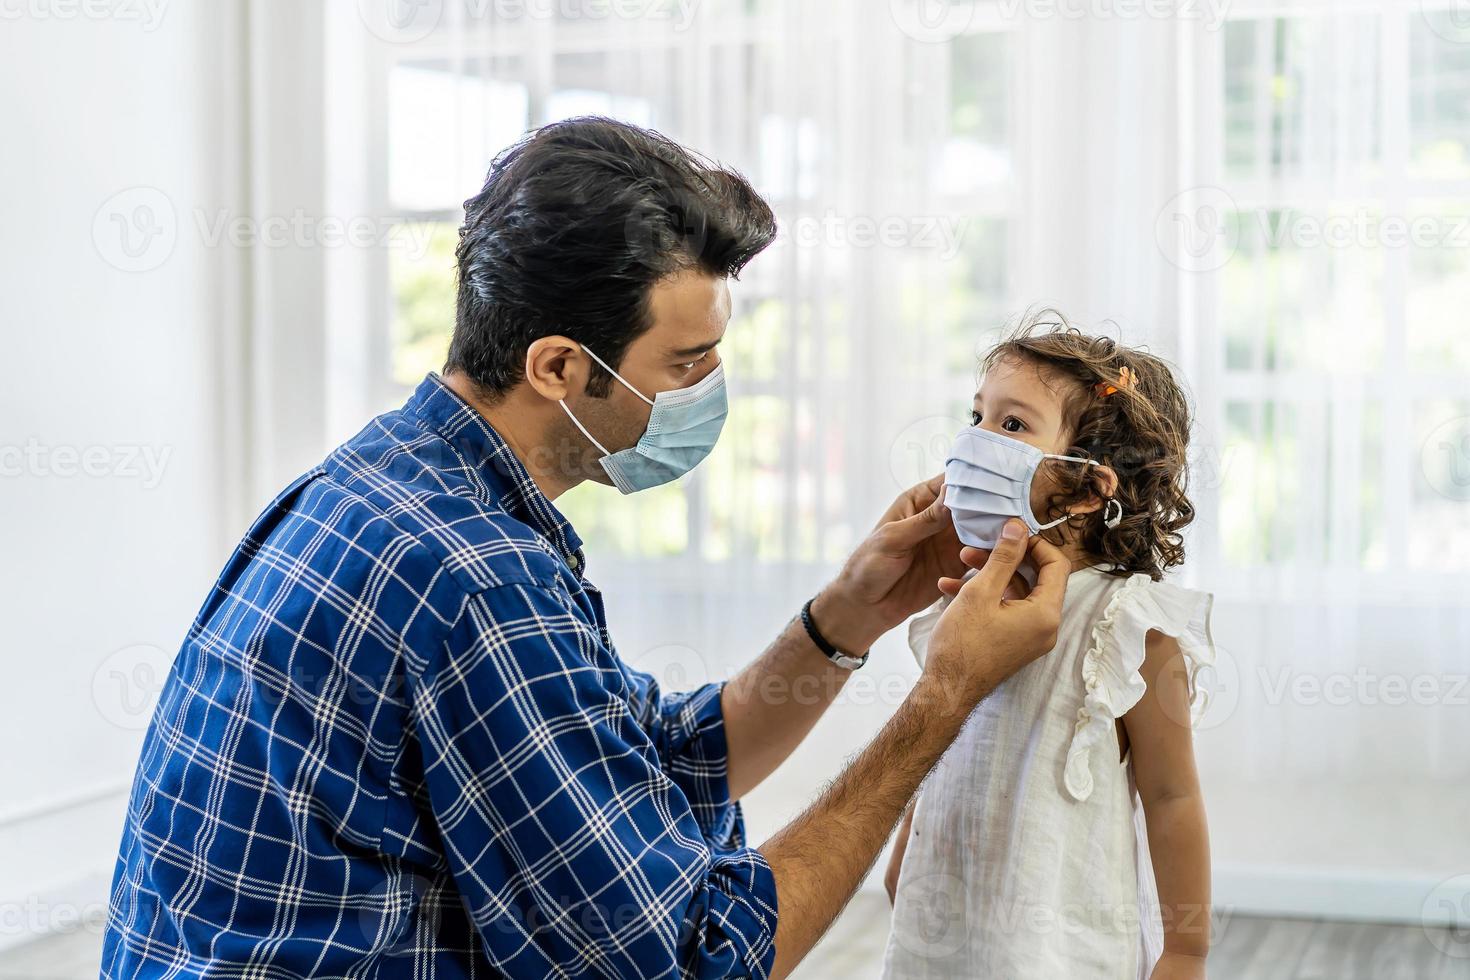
[349,3,1013,575]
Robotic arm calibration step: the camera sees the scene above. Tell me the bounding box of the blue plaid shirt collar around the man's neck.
[403,373,587,576]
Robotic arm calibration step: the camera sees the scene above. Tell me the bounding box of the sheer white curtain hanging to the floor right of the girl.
[1158,3,1470,918]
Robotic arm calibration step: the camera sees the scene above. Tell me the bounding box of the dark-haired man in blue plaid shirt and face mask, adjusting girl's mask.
[103,119,1066,979]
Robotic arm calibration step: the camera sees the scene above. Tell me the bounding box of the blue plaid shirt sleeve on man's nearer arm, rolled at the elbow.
[410,585,776,977]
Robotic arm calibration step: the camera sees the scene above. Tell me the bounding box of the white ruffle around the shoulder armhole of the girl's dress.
[1064,573,1214,802]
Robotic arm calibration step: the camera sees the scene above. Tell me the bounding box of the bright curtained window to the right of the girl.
[1197,4,1470,588]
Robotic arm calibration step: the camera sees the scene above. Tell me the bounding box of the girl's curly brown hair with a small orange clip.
[982,310,1195,580]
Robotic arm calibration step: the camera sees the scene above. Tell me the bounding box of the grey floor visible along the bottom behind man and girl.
[0,892,1470,980]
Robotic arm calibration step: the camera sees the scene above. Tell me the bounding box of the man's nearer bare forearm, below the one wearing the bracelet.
[760,676,973,977]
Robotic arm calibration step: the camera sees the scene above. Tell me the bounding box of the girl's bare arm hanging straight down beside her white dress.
[1123,630,1210,980]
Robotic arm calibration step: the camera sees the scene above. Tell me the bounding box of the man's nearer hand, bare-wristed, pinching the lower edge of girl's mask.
[925,520,1069,710]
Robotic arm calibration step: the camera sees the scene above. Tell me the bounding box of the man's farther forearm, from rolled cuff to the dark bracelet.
[720,591,876,799]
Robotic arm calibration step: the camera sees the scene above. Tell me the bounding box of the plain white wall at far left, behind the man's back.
[0,3,241,945]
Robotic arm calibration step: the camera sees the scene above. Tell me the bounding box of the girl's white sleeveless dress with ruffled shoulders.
[883,569,1214,980]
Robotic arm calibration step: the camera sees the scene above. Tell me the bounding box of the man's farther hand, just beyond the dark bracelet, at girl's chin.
[811,473,966,654]
